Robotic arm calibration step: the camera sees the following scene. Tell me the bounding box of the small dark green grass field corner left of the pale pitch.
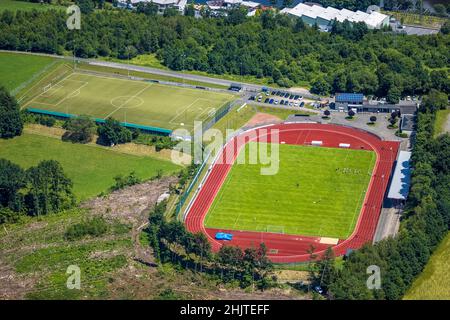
[0,51,55,91]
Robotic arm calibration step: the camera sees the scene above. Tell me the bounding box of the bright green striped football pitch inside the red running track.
[205,144,376,239]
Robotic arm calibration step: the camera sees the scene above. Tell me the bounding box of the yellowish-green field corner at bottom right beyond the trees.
[404,233,450,300]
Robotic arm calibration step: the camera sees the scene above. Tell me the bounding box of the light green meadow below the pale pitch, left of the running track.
[0,134,180,200]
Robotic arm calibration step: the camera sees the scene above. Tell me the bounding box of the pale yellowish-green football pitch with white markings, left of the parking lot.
[24,72,236,130]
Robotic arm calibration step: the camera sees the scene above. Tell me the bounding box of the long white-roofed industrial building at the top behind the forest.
[281,3,389,30]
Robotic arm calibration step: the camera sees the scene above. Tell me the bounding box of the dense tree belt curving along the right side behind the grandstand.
[313,92,450,299]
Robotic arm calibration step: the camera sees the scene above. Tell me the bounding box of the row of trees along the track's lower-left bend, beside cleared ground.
[146,202,274,289]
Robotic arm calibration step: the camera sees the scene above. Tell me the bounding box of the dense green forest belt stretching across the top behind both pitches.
[0,8,450,100]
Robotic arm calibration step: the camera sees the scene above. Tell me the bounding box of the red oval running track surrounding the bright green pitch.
[185,123,399,263]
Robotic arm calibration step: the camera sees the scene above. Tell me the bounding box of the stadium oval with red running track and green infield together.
[184,122,399,263]
